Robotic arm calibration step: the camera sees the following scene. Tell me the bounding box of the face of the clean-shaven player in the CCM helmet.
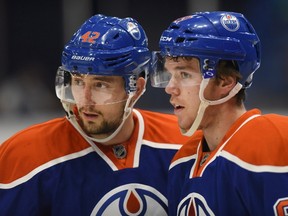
[165,58,202,130]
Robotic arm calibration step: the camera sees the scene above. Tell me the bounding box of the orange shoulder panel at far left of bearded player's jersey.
[0,118,90,183]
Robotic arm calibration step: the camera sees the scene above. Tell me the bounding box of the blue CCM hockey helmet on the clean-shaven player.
[159,11,261,88]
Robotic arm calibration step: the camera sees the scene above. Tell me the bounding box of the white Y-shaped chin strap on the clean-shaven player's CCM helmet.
[180,78,242,136]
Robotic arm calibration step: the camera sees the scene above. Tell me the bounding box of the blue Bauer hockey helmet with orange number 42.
[62,14,151,91]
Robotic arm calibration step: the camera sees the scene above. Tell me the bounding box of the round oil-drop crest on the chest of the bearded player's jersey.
[91,184,167,216]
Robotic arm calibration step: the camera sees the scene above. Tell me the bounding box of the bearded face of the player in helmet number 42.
[71,75,127,139]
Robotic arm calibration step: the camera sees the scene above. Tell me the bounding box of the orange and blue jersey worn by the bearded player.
[0,110,187,216]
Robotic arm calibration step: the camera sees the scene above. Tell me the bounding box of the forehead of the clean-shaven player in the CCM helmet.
[164,57,200,70]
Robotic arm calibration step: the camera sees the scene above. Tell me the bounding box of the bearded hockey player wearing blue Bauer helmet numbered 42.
[0,14,187,216]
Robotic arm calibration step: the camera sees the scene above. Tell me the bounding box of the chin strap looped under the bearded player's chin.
[63,92,137,143]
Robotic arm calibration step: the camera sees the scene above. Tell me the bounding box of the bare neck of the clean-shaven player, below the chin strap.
[201,100,246,151]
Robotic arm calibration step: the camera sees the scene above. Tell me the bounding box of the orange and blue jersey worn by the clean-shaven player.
[168,109,288,216]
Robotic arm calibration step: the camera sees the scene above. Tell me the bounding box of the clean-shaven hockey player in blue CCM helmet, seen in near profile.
[151,11,288,216]
